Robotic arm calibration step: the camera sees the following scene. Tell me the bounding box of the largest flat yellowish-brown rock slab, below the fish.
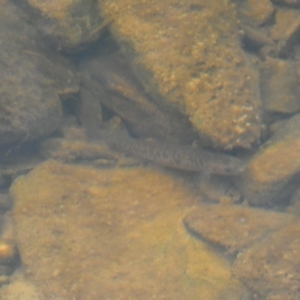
[10,161,245,300]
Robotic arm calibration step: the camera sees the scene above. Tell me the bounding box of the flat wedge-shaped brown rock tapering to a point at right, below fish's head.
[184,205,295,253]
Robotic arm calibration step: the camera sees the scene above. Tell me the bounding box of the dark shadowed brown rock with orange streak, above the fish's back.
[81,47,195,143]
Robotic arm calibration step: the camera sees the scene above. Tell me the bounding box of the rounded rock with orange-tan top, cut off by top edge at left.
[18,0,107,52]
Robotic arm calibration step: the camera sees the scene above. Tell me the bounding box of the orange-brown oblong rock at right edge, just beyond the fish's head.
[235,114,300,205]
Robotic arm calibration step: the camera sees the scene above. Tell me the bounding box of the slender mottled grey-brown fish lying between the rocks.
[89,130,246,175]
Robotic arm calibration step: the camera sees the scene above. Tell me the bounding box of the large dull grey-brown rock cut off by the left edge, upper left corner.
[0,0,75,145]
